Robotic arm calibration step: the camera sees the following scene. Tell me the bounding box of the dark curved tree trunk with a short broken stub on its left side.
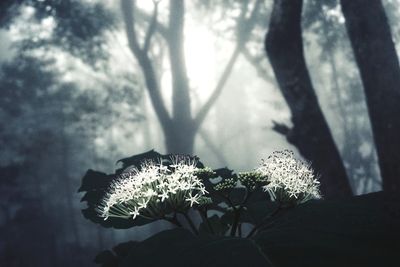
[265,0,352,197]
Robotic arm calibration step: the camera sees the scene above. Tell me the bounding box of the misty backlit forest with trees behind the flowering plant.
[0,0,400,266]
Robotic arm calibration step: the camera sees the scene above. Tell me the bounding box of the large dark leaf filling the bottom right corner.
[254,192,400,267]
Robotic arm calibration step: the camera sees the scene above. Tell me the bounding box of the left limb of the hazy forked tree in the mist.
[121,0,171,131]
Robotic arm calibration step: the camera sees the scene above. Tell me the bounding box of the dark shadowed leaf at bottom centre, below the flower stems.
[120,228,272,267]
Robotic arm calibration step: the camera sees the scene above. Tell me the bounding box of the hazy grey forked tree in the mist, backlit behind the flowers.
[120,0,262,154]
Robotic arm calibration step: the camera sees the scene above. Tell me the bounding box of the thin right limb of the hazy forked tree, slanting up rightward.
[195,0,262,130]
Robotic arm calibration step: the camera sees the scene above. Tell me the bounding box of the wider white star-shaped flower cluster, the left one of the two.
[97,156,207,220]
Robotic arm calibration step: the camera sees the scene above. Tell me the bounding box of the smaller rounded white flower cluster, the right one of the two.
[257,150,321,205]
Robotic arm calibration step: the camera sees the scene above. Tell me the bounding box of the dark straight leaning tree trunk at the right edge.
[341,0,400,191]
